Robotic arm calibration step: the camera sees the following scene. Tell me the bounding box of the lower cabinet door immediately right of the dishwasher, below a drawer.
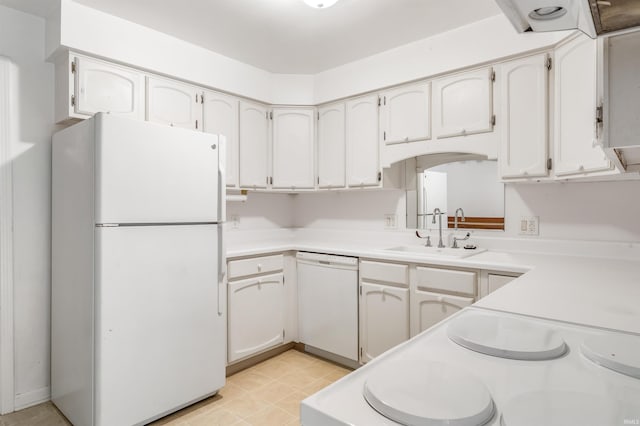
[360,281,409,363]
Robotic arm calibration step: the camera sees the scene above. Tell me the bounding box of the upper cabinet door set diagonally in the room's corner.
[272,108,315,190]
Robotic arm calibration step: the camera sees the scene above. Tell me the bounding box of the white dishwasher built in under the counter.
[296,252,358,361]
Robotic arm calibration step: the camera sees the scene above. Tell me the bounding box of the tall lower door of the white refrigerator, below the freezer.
[95,225,226,426]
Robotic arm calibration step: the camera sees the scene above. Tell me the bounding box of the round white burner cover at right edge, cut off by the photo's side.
[580,334,640,379]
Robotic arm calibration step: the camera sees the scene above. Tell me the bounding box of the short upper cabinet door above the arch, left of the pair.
[381,83,431,145]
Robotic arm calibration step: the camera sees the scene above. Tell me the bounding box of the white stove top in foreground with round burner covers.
[301,308,640,426]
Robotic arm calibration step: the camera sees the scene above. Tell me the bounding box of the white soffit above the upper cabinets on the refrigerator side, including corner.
[47,0,313,105]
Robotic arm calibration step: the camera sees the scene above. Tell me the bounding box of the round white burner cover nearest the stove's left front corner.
[363,361,495,426]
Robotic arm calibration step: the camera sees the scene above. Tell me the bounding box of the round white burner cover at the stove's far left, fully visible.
[447,312,567,360]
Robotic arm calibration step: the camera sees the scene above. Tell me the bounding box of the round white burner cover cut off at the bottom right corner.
[500,391,640,426]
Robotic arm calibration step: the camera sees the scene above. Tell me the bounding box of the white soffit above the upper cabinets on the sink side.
[314,14,571,103]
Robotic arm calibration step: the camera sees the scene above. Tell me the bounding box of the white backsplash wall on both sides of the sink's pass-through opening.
[294,181,640,242]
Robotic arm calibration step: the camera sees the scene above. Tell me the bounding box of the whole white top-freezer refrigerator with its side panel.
[51,114,226,426]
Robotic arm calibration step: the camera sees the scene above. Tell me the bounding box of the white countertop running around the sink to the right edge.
[227,232,640,334]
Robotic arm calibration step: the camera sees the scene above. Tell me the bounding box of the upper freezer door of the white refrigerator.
[95,114,220,223]
